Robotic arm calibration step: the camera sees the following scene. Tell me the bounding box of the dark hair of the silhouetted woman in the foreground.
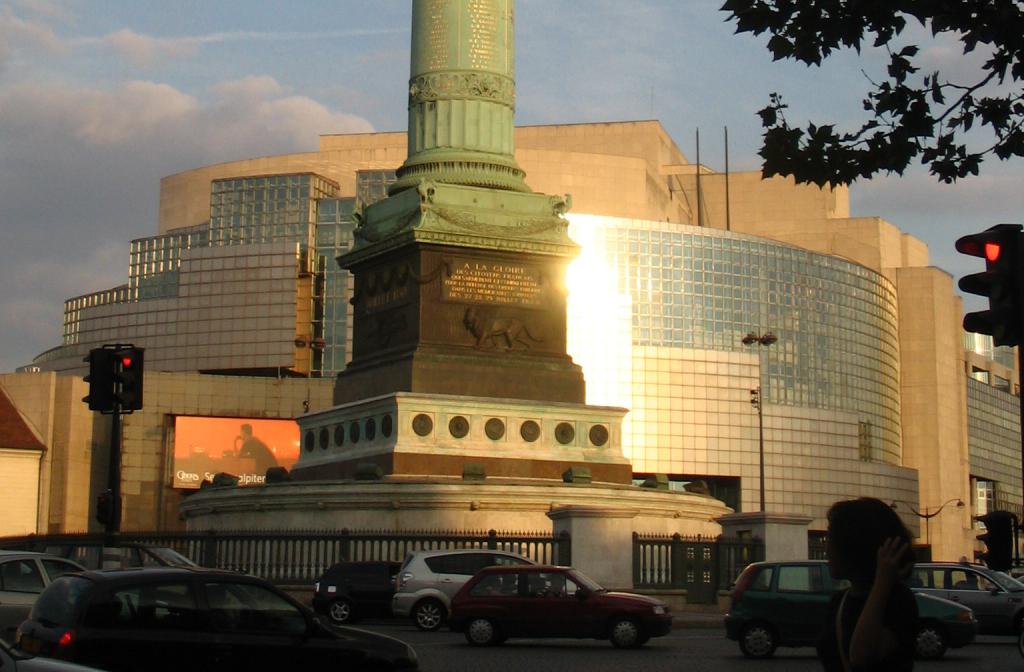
[827,497,912,582]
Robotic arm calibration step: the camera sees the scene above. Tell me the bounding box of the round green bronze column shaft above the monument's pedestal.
[390,0,529,194]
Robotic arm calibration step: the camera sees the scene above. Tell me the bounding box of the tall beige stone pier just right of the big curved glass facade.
[896,267,974,560]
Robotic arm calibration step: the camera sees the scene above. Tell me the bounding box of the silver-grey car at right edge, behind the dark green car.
[908,562,1024,635]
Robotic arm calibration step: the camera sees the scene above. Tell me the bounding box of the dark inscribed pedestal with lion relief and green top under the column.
[334,182,585,404]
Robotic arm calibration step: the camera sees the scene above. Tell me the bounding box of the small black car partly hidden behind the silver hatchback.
[313,561,401,625]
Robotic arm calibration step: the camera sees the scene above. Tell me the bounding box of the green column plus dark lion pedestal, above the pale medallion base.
[335,0,585,404]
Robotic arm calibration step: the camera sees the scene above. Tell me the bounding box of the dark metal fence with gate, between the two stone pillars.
[633,533,765,604]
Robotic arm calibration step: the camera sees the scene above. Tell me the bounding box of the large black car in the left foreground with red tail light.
[16,568,418,672]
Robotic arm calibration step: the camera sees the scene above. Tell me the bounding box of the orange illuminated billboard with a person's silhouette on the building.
[174,416,299,490]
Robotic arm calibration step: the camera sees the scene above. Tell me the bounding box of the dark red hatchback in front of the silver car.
[449,565,672,648]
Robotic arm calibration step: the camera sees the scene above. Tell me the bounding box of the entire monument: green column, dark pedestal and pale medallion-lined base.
[282,0,632,484]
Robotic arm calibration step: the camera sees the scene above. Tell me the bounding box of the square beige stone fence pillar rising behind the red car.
[548,506,637,589]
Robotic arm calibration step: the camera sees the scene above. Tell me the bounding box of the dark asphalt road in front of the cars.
[357,621,1024,672]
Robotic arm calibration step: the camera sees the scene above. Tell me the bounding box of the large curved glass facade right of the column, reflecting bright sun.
[569,215,900,464]
